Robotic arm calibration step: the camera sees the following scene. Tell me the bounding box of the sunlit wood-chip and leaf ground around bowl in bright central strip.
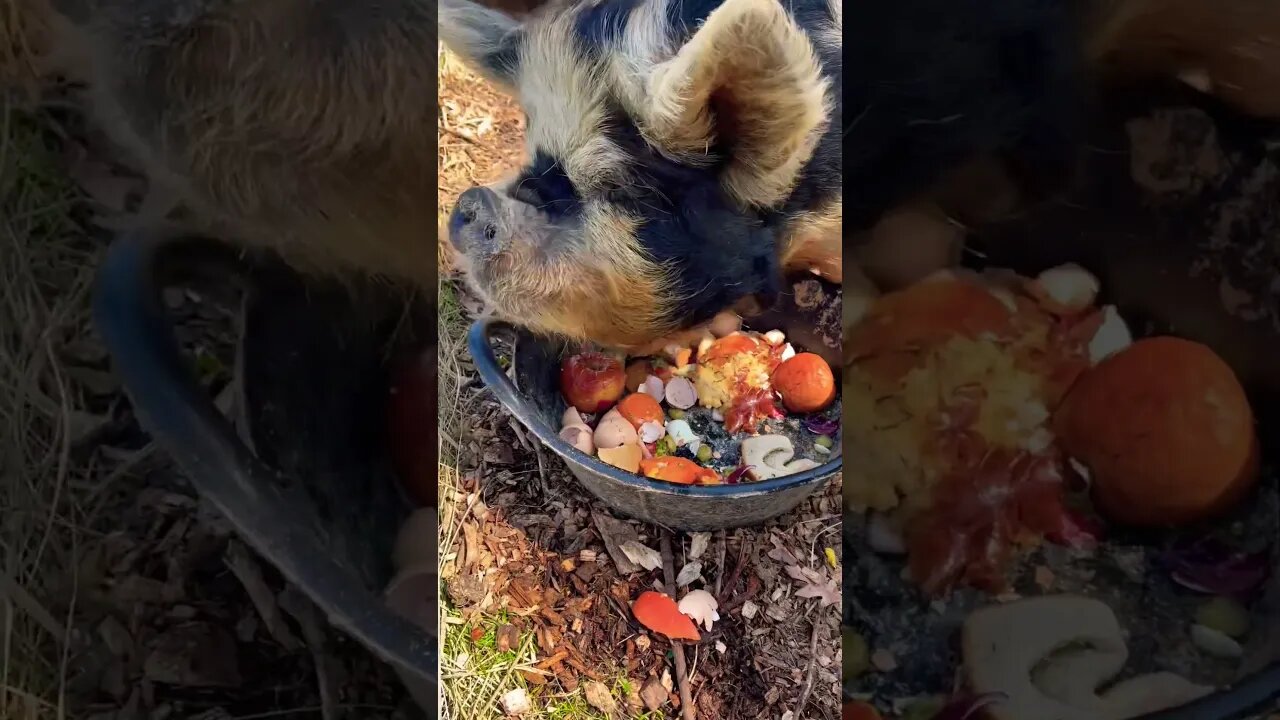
[440,49,841,720]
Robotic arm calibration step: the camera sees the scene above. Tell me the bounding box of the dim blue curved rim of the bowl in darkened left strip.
[93,234,436,689]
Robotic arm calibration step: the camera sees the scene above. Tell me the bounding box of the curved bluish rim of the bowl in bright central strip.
[467,318,844,497]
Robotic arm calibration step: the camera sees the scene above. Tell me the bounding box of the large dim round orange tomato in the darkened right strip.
[1055,337,1258,527]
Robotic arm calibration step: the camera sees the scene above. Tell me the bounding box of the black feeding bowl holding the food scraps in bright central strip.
[468,275,841,530]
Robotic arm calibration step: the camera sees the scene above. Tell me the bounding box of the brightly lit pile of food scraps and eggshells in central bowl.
[559,325,840,486]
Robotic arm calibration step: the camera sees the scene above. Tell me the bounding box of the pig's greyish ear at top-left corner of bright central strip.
[439,0,522,87]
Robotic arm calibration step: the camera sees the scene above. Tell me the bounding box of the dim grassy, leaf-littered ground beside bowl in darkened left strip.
[0,79,412,720]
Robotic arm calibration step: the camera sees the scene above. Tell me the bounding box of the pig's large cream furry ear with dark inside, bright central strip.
[645,0,831,206]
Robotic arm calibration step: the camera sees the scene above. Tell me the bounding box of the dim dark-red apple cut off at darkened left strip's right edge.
[387,352,439,507]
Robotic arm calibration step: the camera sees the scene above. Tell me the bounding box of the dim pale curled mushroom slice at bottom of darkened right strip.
[961,594,1213,720]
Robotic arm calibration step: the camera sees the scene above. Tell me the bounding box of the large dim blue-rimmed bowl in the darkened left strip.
[93,237,436,710]
